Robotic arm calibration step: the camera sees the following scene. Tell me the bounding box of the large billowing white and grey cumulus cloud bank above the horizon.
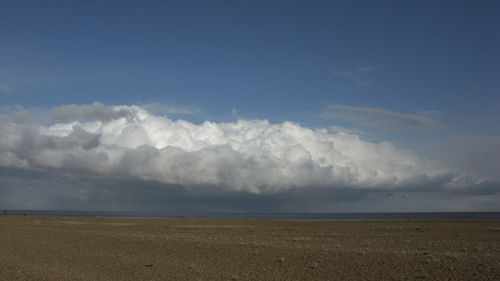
[0,103,460,194]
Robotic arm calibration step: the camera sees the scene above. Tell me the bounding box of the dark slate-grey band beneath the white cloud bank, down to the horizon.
[0,168,500,212]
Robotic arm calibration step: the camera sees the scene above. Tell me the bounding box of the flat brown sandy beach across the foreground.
[0,216,500,280]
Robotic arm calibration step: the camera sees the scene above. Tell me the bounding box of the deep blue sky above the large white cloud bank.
[0,1,500,210]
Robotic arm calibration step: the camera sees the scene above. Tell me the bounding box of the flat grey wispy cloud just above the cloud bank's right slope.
[321,104,442,131]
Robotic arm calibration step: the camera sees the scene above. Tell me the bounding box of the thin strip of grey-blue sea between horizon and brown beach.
[1,210,500,221]
